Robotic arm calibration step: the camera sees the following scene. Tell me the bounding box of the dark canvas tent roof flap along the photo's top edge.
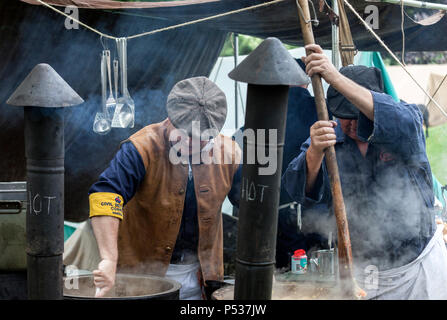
[21,0,447,51]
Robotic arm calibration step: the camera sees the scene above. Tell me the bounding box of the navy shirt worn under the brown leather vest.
[89,142,242,263]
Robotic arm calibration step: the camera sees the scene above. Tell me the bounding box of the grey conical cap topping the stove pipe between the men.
[228,37,310,86]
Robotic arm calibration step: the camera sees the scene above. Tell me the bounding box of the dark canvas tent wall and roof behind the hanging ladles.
[0,0,447,221]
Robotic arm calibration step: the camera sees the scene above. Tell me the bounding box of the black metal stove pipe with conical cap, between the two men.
[229,38,309,300]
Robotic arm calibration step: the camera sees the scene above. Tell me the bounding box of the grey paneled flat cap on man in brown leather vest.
[166,77,227,137]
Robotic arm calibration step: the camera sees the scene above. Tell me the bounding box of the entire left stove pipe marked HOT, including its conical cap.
[7,64,83,299]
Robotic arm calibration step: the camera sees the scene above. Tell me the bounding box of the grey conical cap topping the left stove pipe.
[6,63,84,108]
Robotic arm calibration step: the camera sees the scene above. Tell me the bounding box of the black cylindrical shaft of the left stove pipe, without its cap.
[25,107,64,299]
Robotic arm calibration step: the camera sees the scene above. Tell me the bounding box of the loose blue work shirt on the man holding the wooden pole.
[282,91,435,270]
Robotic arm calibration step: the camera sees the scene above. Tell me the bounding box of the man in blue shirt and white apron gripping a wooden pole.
[282,45,447,299]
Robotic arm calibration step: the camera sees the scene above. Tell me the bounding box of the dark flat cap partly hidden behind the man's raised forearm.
[327,65,384,119]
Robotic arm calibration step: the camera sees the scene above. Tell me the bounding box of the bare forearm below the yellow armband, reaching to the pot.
[91,216,120,261]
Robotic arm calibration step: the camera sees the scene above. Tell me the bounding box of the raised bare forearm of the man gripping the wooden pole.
[331,74,374,121]
